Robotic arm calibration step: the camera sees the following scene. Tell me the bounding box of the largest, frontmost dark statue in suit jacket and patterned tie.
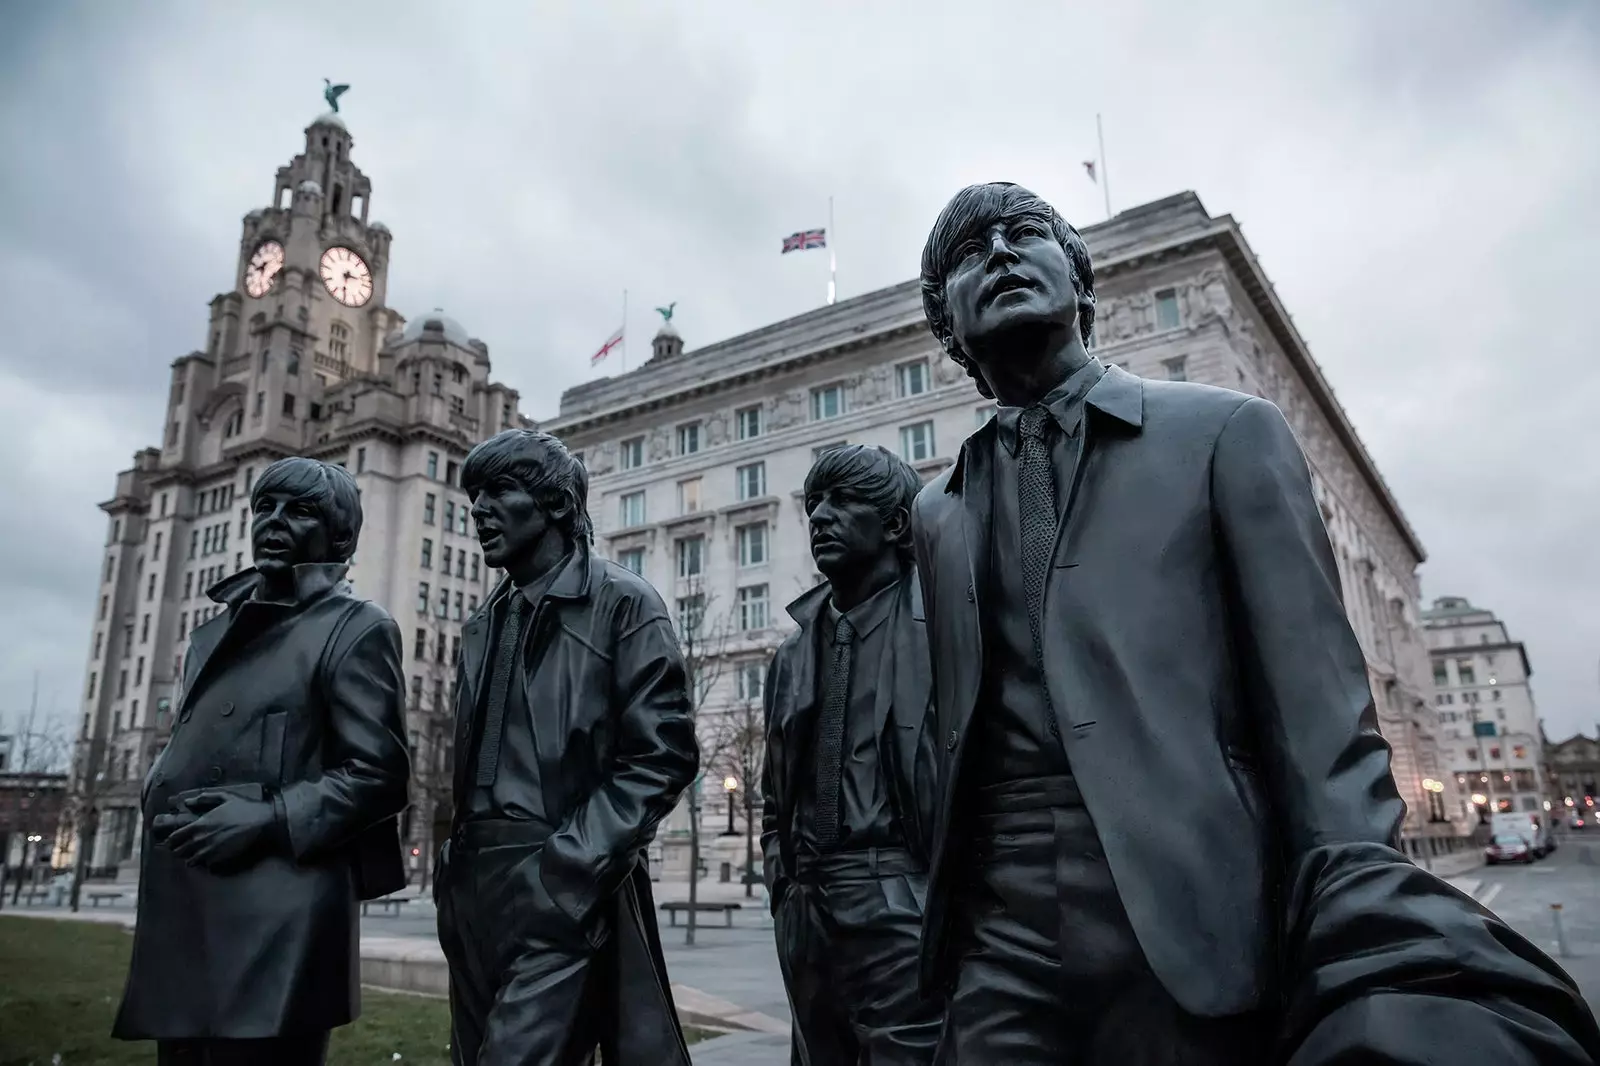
[915,184,1600,1066]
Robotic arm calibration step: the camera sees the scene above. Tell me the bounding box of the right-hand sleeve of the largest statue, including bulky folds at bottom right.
[1211,399,1600,1066]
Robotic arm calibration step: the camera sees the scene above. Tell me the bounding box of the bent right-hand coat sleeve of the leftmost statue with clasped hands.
[278,615,411,861]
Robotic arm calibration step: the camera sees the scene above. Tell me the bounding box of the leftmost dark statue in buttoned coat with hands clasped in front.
[114,458,410,1066]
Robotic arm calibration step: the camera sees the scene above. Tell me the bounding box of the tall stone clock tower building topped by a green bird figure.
[74,114,523,874]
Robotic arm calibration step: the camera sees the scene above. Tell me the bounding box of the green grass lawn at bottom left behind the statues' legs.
[0,917,709,1066]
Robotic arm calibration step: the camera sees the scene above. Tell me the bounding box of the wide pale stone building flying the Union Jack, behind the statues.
[544,192,1462,855]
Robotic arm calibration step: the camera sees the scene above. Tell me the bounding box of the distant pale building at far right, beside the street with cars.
[1422,595,1550,821]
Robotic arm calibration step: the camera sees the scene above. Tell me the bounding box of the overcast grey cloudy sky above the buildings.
[0,0,1600,736]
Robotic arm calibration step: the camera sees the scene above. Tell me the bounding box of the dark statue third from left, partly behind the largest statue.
[762,445,941,1066]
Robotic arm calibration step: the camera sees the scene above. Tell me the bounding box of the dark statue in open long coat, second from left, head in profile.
[434,429,699,1066]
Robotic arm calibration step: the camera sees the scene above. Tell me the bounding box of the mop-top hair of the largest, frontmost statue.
[922,181,1094,400]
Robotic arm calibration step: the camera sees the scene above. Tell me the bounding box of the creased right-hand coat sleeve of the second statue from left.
[539,592,699,927]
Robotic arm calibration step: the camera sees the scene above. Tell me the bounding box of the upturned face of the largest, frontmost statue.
[944,218,1078,359]
